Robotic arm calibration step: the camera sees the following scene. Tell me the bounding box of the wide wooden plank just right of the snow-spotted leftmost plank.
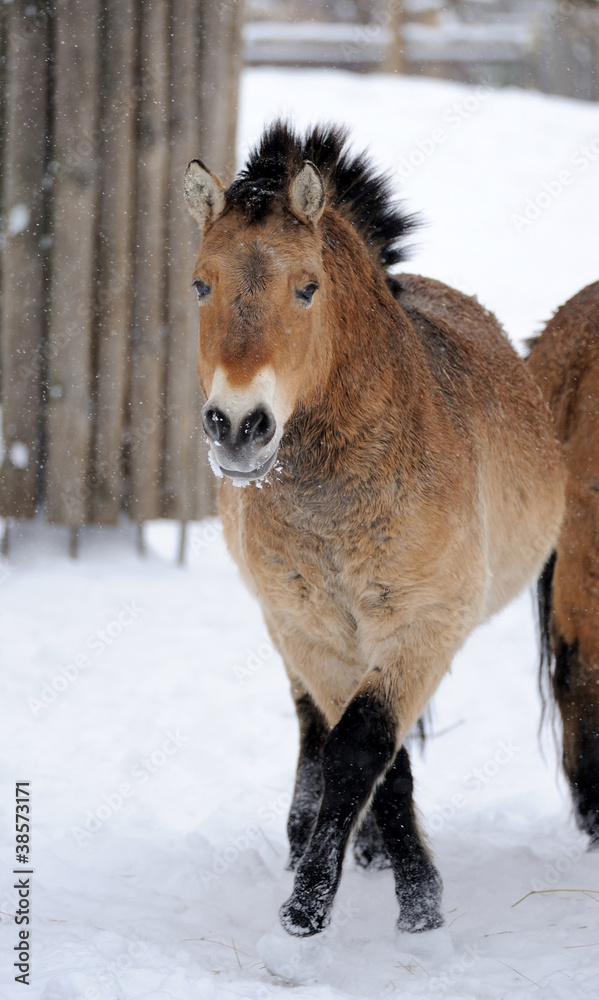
[47,0,99,527]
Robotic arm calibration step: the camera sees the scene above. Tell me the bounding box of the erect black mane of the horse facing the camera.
[227,120,418,276]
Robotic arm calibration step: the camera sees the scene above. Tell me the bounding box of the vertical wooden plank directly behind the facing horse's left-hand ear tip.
[163,0,203,521]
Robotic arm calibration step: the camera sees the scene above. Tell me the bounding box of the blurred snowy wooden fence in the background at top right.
[244,0,599,101]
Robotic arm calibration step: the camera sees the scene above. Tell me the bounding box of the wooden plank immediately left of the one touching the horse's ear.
[129,0,169,522]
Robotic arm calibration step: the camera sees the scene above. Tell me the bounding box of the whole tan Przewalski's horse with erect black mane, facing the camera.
[185,122,563,935]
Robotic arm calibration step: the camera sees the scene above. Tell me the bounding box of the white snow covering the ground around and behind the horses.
[0,71,599,1000]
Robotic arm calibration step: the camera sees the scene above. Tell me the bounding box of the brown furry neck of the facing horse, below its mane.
[290,216,431,488]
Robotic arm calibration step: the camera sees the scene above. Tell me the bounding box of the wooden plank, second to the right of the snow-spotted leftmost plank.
[91,0,137,524]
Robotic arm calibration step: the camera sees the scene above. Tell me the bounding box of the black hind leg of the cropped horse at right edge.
[553,635,599,848]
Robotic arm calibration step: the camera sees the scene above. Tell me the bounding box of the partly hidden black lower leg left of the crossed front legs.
[287,694,329,871]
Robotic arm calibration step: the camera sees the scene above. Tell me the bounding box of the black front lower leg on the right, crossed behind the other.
[371,747,443,931]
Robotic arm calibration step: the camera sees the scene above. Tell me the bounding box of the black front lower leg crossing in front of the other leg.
[280,694,395,936]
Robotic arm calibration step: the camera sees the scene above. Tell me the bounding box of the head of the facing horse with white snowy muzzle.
[185,160,326,480]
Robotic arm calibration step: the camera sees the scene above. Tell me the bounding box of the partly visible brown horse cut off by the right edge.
[528,281,599,846]
